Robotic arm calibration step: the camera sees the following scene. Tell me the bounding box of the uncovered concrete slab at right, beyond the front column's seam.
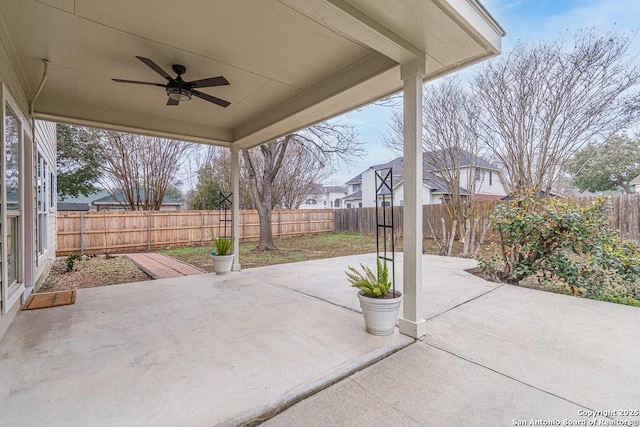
[265,258,640,426]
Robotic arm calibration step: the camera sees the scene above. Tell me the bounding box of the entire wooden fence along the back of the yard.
[56,194,640,256]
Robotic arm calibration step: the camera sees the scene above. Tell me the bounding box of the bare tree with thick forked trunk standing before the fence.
[242,121,363,251]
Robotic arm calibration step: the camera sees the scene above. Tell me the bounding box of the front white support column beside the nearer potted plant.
[399,60,427,338]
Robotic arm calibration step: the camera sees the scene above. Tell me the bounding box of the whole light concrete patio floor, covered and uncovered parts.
[0,255,640,426]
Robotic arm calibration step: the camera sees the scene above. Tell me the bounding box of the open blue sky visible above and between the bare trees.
[325,0,640,184]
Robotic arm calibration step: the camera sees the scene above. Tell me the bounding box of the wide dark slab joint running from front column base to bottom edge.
[238,339,417,427]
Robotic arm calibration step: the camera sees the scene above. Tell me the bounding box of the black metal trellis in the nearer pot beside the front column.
[375,168,396,297]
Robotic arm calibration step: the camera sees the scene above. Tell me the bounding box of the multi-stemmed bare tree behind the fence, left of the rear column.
[95,130,193,210]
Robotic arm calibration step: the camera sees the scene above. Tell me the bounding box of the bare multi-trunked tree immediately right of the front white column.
[385,77,488,256]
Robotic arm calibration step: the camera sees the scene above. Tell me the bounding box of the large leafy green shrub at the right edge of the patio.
[479,193,640,301]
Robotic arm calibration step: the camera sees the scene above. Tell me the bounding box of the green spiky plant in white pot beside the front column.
[345,258,402,335]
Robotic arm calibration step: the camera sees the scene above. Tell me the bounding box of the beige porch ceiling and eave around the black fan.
[0,0,503,148]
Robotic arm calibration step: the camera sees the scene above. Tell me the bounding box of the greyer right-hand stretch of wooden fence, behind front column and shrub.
[334,194,640,242]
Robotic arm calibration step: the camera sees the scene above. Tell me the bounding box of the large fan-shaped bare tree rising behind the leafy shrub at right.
[475,30,640,196]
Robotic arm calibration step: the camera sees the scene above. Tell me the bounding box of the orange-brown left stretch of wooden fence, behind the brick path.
[56,209,334,256]
